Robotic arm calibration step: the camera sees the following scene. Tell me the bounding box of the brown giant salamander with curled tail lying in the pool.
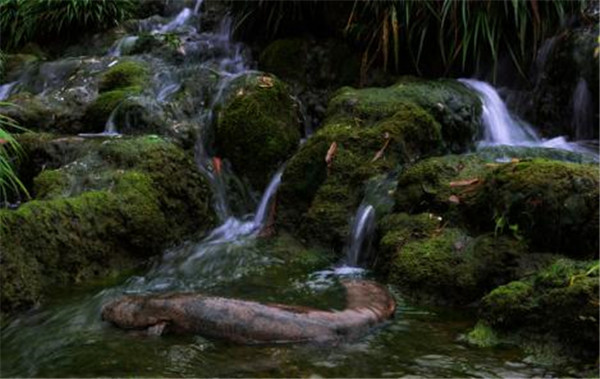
[102,280,396,344]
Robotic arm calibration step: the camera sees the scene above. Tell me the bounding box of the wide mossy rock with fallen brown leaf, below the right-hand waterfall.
[395,152,599,256]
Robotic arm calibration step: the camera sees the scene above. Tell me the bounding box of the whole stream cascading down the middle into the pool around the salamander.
[0,1,592,377]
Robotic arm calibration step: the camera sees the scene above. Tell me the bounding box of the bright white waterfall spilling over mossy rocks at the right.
[459,79,588,152]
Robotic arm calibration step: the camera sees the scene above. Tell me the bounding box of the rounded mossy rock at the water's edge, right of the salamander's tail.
[390,232,526,304]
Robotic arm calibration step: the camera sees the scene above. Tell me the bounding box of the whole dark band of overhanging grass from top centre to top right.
[231,0,586,83]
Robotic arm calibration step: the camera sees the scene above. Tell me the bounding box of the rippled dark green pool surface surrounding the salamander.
[1,241,560,377]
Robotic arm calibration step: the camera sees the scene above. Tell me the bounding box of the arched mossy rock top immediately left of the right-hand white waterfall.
[326,78,481,152]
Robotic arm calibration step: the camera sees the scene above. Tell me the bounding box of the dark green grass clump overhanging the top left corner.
[0,0,137,48]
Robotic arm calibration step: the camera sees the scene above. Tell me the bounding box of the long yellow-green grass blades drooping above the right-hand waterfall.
[345,0,585,83]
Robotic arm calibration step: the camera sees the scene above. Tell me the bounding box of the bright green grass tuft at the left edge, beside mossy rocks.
[0,102,29,203]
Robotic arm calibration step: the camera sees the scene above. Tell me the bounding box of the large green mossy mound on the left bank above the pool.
[0,137,214,312]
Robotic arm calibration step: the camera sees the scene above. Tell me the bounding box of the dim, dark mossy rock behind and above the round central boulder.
[259,38,308,80]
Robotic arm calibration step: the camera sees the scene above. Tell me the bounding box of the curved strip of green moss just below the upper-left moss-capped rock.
[84,86,142,132]
